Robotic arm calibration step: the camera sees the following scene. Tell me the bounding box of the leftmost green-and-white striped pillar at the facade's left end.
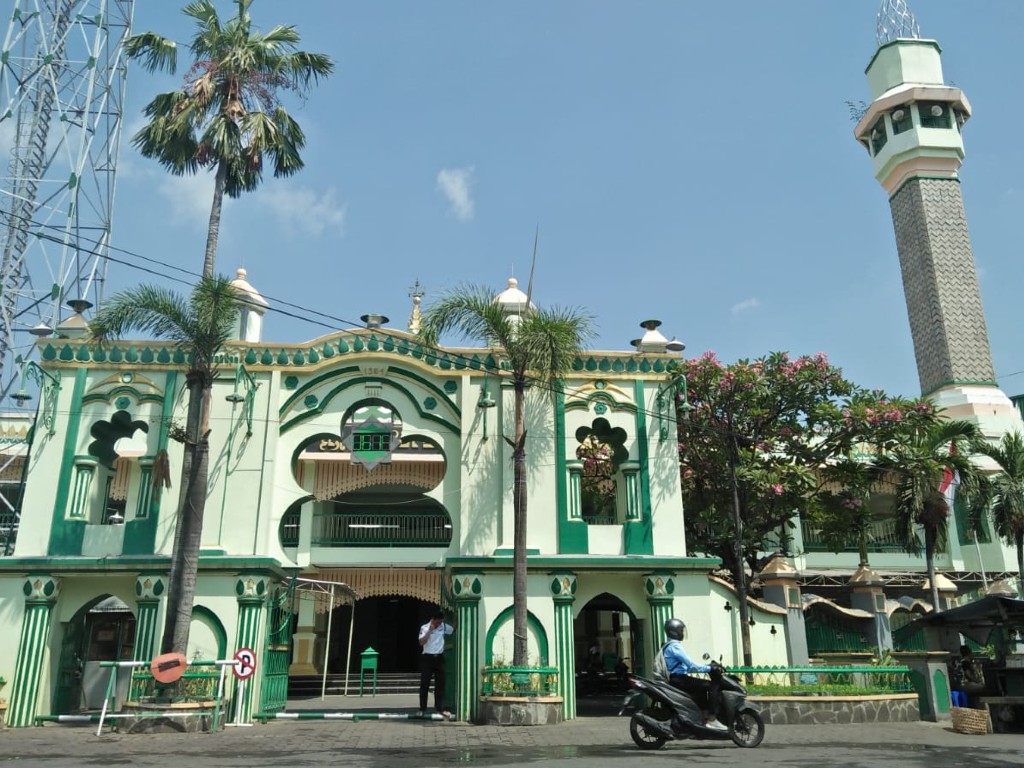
[7,575,60,728]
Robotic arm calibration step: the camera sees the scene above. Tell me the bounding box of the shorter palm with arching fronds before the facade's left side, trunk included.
[89,278,239,653]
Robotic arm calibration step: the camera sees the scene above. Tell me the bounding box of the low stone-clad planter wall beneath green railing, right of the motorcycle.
[750,693,921,725]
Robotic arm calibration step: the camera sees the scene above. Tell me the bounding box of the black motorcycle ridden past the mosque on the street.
[618,664,765,750]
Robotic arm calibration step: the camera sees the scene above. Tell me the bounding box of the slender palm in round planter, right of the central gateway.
[420,286,593,667]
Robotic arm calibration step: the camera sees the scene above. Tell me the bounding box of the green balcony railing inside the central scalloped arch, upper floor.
[312,510,452,547]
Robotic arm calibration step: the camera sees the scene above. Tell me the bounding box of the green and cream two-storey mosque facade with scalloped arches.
[0,270,791,726]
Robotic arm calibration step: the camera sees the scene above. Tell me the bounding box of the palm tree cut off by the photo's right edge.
[971,431,1024,598]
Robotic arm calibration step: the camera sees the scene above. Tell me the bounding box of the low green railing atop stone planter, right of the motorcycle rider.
[729,666,914,696]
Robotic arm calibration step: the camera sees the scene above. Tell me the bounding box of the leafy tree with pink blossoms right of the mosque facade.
[678,352,913,666]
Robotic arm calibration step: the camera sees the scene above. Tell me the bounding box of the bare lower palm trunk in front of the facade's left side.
[161,372,212,653]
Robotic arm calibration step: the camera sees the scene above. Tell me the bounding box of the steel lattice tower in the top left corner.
[0,0,134,400]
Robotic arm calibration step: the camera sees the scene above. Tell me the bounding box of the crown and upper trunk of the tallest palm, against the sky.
[125,0,334,278]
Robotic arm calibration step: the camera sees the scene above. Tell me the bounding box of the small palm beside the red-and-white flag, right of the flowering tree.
[879,420,981,610]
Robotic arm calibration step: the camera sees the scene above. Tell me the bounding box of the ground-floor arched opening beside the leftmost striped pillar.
[53,595,135,715]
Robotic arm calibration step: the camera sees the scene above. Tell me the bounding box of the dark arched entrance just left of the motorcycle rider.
[573,592,640,701]
